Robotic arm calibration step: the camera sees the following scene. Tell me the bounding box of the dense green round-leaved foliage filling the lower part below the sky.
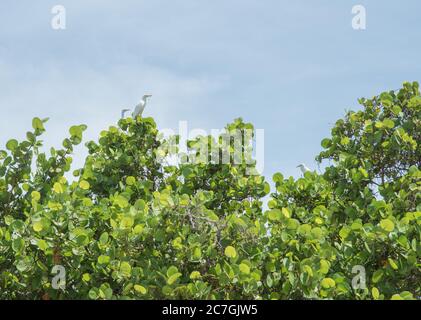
[0,83,421,300]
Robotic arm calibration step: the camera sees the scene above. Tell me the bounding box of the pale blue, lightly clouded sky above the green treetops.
[0,0,421,177]
